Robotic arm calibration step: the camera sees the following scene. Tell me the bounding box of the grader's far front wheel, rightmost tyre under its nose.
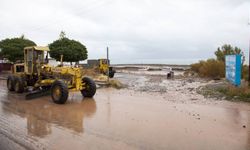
[81,77,96,98]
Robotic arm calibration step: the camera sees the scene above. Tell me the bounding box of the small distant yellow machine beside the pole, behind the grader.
[98,59,116,78]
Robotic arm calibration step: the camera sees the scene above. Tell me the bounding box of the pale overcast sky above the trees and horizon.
[0,0,250,64]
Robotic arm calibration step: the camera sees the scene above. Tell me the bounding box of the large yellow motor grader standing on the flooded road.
[7,46,96,104]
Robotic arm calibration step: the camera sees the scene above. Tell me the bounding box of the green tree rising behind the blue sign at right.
[214,44,245,63]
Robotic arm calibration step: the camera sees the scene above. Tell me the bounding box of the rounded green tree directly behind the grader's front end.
[49,32,88,63]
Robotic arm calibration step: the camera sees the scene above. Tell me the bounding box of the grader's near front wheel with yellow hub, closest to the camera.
[51,80,69,104]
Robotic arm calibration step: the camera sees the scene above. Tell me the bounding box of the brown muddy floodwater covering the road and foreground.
[0,73,250,150]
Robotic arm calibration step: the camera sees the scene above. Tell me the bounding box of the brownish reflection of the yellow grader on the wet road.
[2,97,96,137]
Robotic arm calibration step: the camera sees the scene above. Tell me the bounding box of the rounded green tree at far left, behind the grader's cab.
[0,35,36,62]
